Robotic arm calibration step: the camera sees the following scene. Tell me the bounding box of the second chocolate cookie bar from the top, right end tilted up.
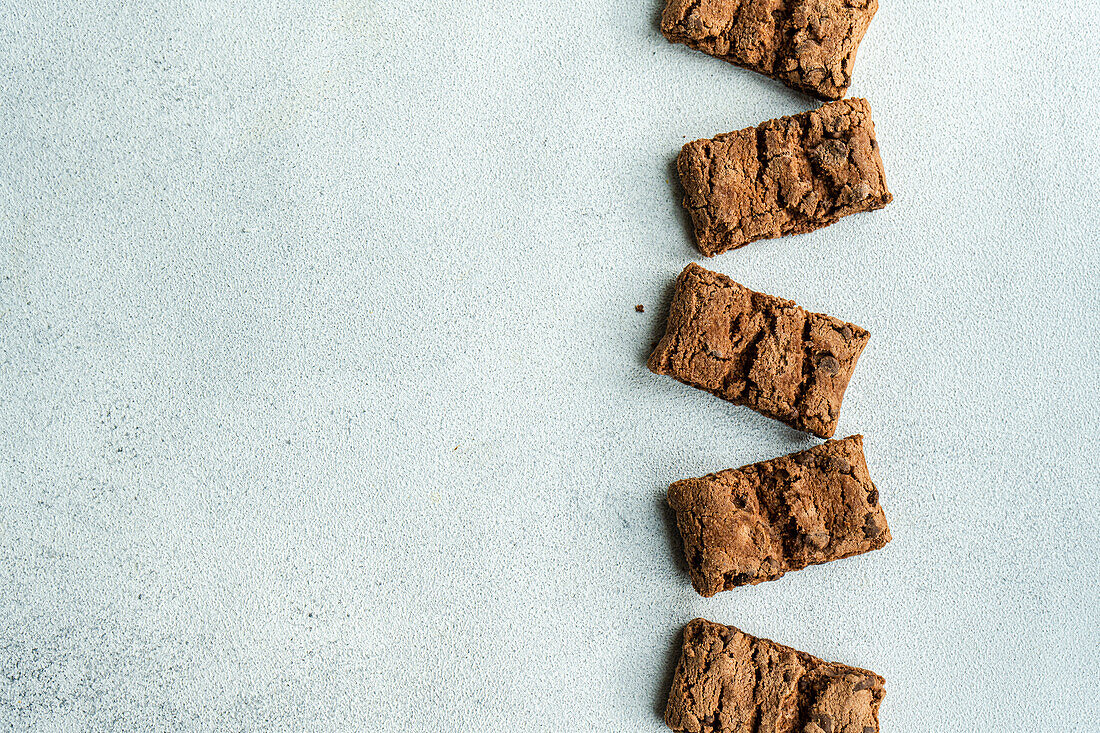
[677,99,893,256]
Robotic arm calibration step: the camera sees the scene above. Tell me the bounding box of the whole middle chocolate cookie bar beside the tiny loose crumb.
[649,263,870,438]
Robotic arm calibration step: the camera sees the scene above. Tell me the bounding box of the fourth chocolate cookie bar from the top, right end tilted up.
[669,435,890,598]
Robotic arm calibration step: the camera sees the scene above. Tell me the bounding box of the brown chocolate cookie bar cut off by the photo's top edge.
[661,0,879,99]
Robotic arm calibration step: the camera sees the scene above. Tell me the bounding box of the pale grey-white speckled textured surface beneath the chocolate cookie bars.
[0,0,1100,733]
